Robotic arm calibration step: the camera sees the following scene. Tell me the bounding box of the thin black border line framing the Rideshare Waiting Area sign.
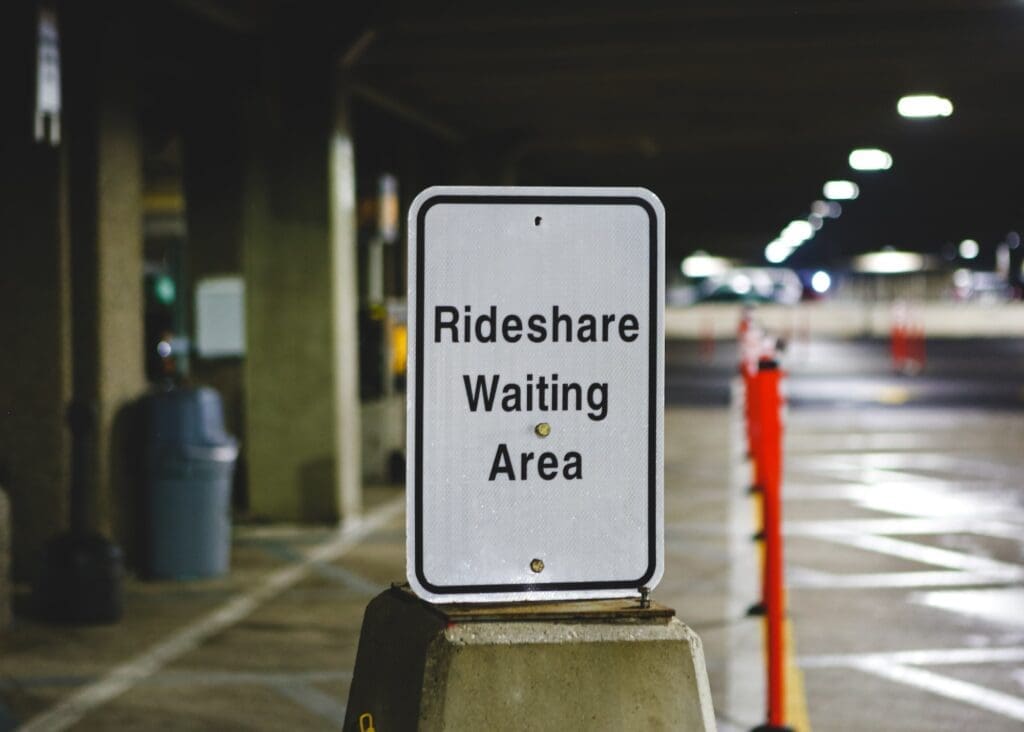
[414,193,660,595]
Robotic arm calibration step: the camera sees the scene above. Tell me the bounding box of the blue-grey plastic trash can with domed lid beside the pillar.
[142,387,239,579]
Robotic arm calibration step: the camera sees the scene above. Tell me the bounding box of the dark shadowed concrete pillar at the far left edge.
[0,2,72,578]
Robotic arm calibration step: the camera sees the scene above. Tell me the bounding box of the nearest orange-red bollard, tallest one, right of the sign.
[755,358,788,732]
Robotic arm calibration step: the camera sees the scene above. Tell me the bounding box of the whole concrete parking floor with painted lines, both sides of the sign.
[0,397,1024,732]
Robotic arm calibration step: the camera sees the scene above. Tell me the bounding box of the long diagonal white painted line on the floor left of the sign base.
[20,497,406,732]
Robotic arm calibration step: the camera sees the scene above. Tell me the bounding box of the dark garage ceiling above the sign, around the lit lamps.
[178,0,1024,265]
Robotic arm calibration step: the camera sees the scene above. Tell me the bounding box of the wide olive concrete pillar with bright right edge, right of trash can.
[243,39,359,521]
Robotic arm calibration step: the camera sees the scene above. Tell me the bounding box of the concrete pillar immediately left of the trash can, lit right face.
[62,2,146,541]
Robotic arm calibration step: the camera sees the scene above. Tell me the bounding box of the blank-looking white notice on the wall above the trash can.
[196,275,246,358]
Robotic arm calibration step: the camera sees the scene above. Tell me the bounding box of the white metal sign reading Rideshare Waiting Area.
[407,186,665,603]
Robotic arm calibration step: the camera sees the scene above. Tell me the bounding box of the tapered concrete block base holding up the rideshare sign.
[345,589,715,731]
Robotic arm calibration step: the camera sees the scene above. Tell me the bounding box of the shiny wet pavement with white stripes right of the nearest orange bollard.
[783,406,1024,730]
